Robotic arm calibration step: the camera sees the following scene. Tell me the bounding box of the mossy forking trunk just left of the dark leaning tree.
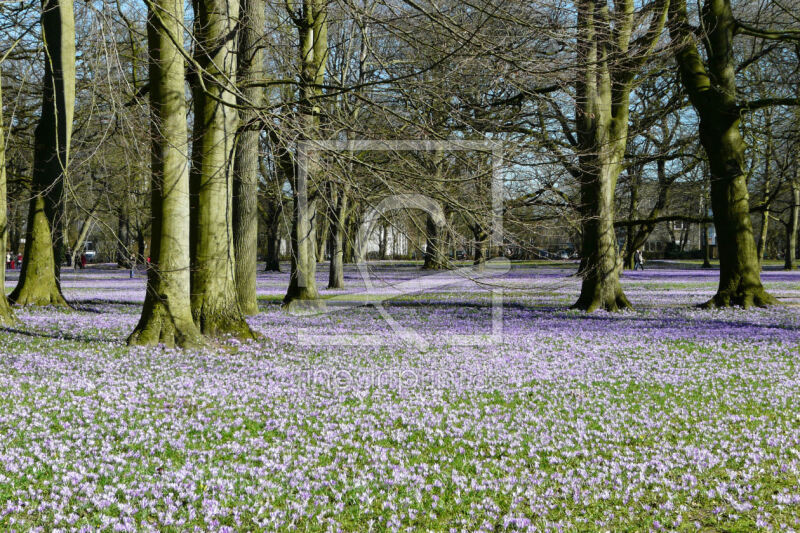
[573,0,669,311]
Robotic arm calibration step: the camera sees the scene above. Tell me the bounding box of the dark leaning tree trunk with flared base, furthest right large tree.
[670,0,777,307]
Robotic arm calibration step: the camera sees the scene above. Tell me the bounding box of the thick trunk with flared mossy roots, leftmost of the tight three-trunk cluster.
[128,0,203,347]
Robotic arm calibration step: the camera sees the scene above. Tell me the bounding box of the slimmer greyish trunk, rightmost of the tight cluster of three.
[233,0,266,315]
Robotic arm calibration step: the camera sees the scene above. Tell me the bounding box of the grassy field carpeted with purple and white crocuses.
[0,264,800,531]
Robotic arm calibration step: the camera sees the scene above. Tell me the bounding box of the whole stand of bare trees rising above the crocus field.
[0,0,800,340]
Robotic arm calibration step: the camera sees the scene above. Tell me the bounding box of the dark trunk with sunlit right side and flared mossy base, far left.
[9,0,75,306]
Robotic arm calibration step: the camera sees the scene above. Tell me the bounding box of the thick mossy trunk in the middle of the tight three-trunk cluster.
[189,0,253,338]
